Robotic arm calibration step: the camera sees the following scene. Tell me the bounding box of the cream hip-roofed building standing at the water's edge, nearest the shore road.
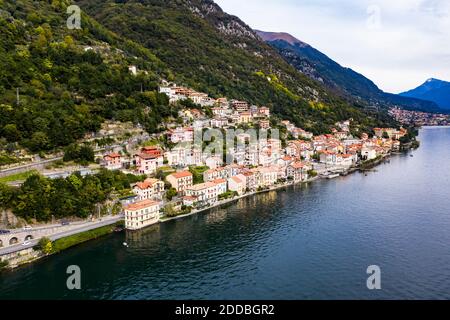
[125,200,161,230]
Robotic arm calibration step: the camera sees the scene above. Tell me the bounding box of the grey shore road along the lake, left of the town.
[0,215,124,256]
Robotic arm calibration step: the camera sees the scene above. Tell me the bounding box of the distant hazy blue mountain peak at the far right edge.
[400,78,450,110]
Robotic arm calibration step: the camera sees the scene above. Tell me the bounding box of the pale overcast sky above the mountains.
[215,0,450,93]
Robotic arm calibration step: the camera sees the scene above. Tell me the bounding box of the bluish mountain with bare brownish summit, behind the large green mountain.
[256,30,437,110]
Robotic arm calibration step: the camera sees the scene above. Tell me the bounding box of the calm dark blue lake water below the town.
[0,128,450,299]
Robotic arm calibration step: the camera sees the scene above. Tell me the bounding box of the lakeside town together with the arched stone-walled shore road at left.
[0,79,408,261]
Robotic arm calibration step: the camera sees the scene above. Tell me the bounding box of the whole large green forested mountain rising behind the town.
[0,0,395,153]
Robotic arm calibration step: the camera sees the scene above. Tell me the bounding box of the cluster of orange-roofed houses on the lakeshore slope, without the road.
[97,83,407,230]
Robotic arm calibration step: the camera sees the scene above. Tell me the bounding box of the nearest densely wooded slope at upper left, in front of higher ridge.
[0,0,181,154]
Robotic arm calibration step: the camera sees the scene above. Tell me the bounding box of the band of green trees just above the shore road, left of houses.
[0,169,145,221]
